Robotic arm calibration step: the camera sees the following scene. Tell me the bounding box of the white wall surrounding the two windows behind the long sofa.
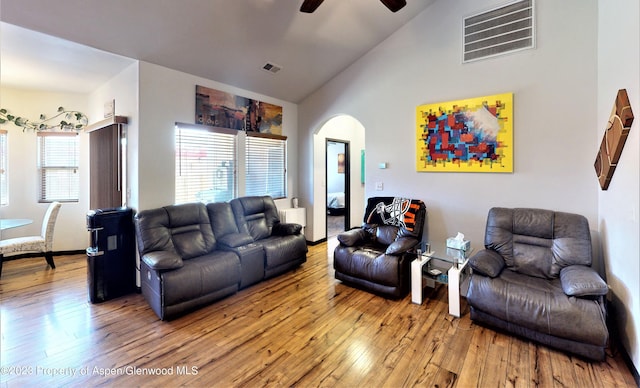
[136,62,298,210]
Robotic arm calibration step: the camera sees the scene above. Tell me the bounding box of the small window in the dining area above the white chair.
[37,132,80,202]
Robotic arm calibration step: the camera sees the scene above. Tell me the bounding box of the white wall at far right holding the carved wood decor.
[595,0,640,370]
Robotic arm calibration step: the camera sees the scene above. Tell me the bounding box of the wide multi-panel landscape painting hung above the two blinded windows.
[196,85,282,135]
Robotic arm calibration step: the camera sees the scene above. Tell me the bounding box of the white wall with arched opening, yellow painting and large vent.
[298,0,598,244]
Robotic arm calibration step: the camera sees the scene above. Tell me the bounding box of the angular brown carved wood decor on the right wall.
[594,89,633,190]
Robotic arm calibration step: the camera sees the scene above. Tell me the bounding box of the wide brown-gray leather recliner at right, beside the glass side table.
[467,208,609,360]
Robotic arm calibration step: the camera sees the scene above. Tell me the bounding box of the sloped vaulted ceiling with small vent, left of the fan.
[0,0,435,102]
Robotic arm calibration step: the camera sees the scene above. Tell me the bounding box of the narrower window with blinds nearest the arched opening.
[245,132,287,198]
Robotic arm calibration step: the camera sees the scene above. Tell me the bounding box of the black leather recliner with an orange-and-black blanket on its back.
[333,197,426,299]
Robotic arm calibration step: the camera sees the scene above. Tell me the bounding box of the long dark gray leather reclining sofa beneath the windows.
[135,196,307,320]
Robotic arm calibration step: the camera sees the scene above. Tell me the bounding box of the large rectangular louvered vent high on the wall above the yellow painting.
[462,0,535,62]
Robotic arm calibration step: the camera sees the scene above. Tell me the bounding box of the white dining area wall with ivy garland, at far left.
[0,87,92,251]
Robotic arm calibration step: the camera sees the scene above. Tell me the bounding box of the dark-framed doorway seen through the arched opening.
[325,139,351,239]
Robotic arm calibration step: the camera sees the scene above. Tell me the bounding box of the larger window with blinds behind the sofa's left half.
[175,124,238,203]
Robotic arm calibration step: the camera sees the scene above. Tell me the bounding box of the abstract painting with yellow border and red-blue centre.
[416,93,513,172]
